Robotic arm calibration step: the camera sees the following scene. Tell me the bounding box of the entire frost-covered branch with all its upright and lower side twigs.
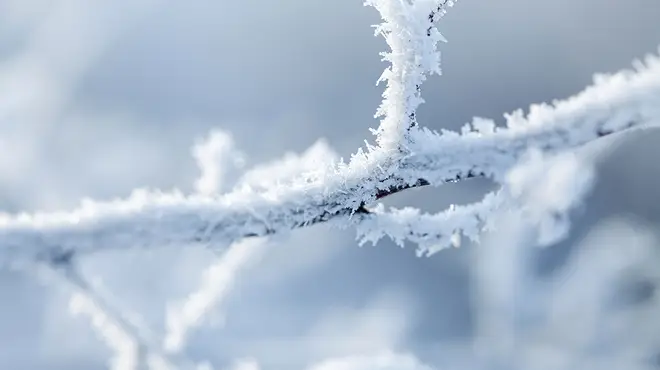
[0,0,660,369]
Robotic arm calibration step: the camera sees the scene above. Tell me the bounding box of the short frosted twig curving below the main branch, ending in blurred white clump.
[357,148,595,256]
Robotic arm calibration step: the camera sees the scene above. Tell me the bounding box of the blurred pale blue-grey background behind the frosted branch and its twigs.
[0,0,660,369]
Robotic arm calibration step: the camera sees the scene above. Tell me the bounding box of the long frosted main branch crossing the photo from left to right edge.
[0,52,660,266]
